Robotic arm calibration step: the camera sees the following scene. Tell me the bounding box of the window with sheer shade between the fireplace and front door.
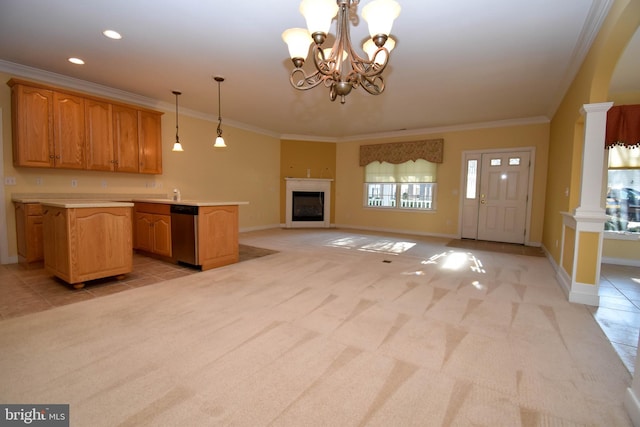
[364,159,437,210]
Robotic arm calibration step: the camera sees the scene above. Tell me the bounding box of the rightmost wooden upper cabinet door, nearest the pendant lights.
[138,111,162,174]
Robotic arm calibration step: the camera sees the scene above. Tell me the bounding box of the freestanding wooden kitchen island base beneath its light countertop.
[43,206,133,288]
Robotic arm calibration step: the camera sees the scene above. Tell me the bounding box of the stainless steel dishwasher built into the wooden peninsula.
[170,205,198,265]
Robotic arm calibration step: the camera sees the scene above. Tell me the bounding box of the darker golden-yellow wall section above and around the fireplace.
[280,140,336,224]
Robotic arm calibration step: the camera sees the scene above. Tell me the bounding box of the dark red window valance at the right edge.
[604,105,640,149]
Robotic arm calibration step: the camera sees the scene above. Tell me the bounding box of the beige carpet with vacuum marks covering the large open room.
[0,230,631,426]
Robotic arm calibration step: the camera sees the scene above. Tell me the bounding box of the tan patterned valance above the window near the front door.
[360,139,444,166]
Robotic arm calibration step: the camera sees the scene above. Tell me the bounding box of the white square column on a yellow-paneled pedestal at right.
[559,102,613,306]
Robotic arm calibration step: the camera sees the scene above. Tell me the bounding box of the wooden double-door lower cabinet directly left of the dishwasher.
[134,203,171,258]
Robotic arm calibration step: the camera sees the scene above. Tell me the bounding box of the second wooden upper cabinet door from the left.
[53,92,85,169]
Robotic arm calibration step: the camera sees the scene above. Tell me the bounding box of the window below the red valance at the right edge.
[605,146,640,233]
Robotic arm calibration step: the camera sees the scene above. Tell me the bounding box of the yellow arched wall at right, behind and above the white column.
[542,0,640,262]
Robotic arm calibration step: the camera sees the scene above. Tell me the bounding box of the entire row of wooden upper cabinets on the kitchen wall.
[7,79,162,174]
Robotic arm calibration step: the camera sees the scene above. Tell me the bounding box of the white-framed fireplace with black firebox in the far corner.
[285,178,333,228]
